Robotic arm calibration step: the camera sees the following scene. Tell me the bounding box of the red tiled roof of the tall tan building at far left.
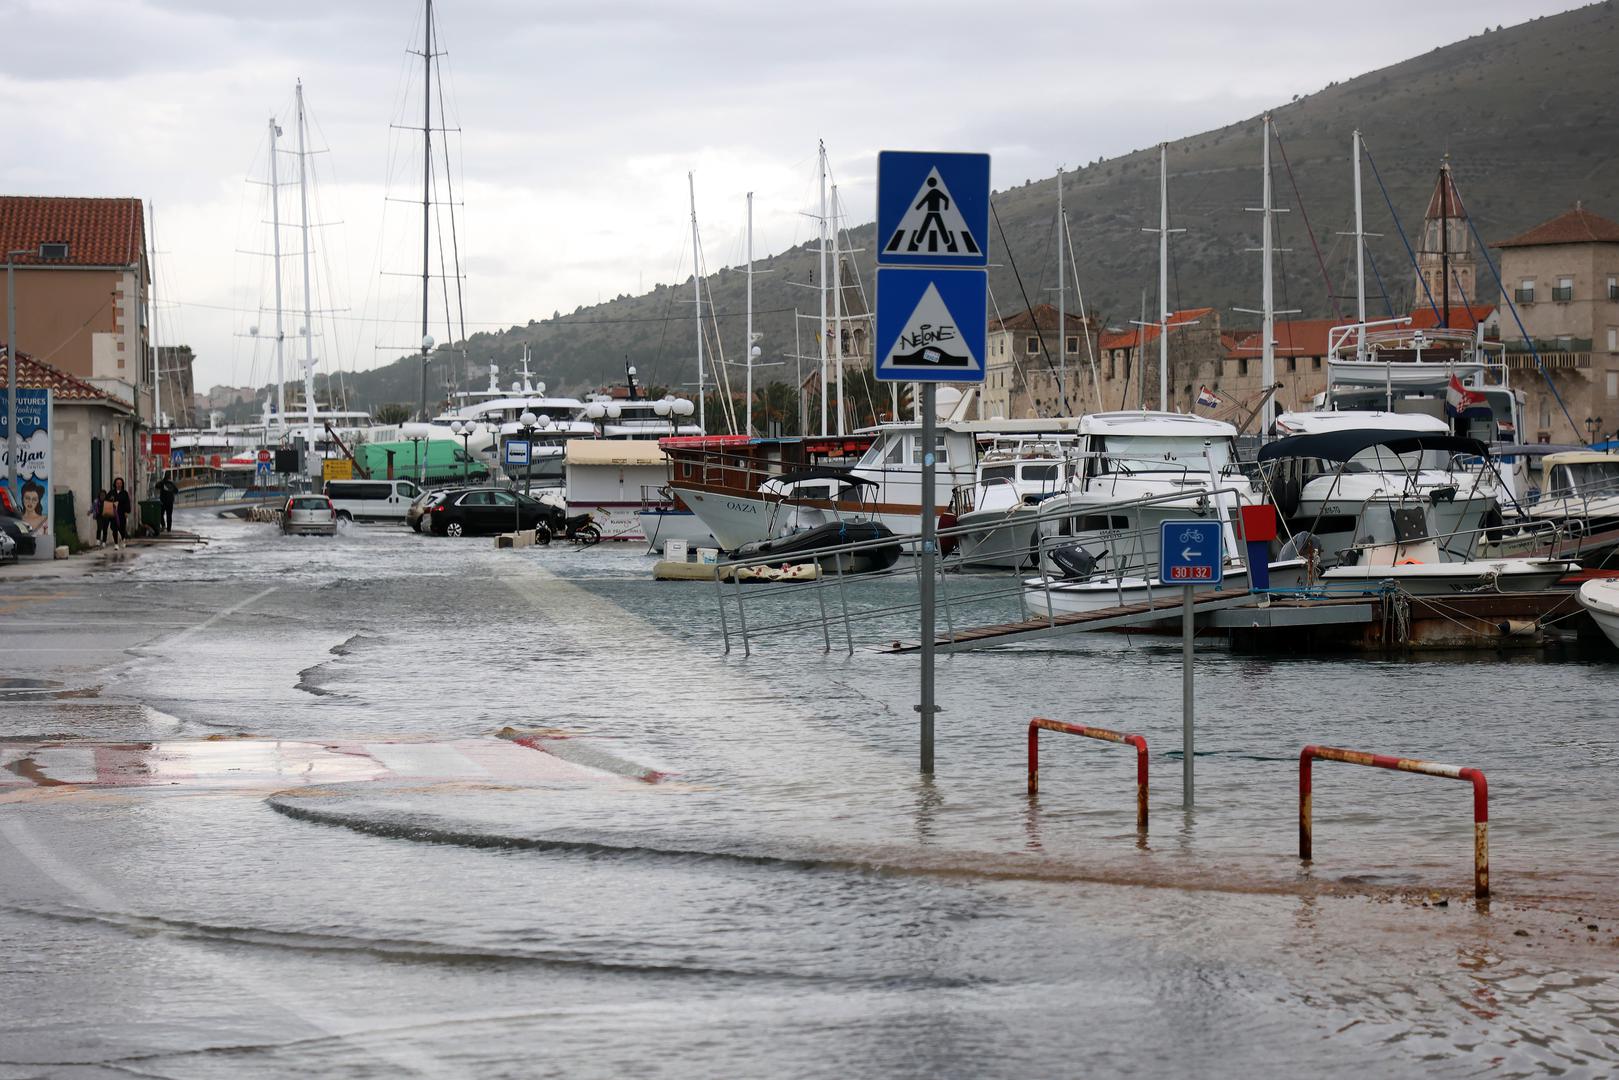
[0,194,146,266]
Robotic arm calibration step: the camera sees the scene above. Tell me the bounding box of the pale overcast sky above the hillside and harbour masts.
[0,0,1572,396]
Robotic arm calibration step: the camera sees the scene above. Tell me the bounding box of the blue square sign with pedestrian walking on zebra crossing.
[877,151,989,267]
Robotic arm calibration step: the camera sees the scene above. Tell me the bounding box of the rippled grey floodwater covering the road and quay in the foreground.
[0,513,1619,1080]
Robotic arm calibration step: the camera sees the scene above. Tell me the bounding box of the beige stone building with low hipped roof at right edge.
[1494,204,1619,442]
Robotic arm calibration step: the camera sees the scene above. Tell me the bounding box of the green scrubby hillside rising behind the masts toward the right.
[318,3,1619,417]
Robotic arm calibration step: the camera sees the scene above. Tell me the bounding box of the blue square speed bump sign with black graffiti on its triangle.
[876,266,989,382]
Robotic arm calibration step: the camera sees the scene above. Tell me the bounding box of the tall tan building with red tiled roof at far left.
[0,196,152,415]
